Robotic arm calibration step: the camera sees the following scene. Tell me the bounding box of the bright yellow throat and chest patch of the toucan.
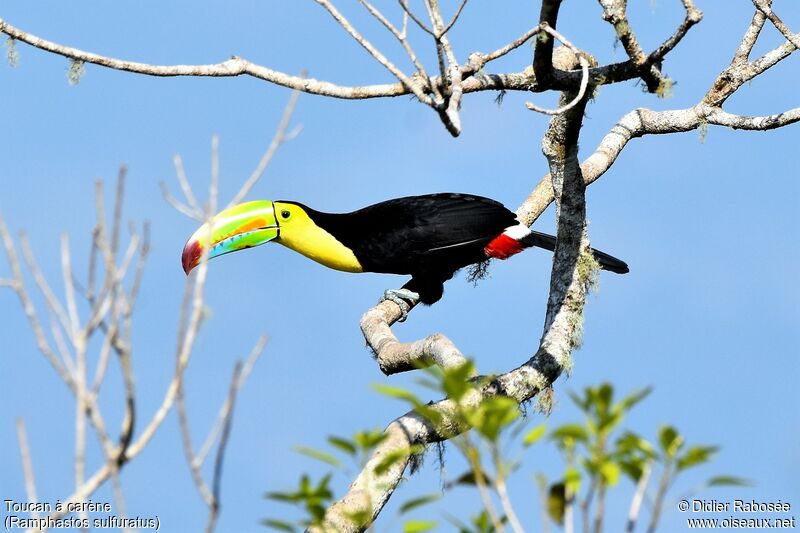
[278,223,364,272]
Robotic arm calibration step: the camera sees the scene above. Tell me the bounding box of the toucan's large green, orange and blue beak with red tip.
[181,200,281,274]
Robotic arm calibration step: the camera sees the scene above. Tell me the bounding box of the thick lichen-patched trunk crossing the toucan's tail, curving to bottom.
[312,52,591,532]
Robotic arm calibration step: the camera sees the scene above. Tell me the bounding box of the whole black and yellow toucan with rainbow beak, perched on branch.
[182,193,628,316]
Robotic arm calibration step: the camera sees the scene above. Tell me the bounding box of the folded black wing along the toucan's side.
[312,193,517,275]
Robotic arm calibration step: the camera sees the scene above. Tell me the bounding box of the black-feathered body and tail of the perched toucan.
[276,193,627,304]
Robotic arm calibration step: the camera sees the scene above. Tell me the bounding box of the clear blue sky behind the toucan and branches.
[0,0,800,531]
